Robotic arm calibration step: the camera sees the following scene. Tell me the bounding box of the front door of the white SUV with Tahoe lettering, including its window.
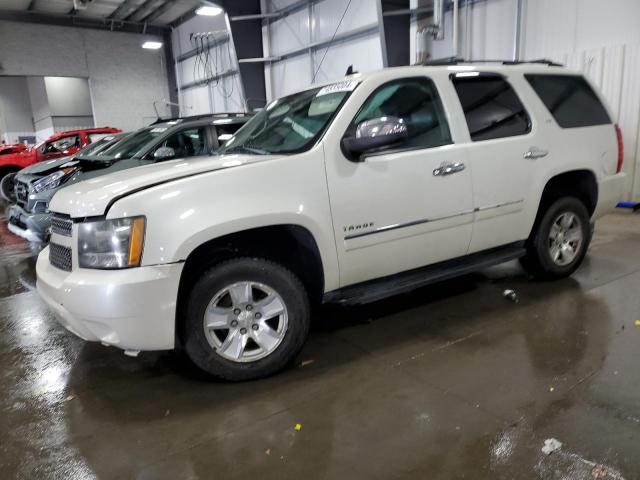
[325,77,473,286]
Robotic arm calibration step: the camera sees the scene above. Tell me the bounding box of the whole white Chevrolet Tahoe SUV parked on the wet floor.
[37,63,624,380]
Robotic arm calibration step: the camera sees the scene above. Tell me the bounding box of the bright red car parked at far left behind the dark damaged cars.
[0,127,122,181]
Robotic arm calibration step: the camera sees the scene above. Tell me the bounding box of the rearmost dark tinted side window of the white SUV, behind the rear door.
[525,75,611,128]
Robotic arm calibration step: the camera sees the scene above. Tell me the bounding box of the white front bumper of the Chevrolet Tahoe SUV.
[36,248,183,350]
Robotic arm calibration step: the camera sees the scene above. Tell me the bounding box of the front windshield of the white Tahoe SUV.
[218,81,358,155]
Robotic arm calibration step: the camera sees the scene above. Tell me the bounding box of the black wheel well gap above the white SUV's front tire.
[176,225,324,342]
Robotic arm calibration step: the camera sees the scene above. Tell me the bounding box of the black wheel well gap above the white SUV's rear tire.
[532,170,598,240]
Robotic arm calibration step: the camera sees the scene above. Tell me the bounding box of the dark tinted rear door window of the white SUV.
[453,75,531,142]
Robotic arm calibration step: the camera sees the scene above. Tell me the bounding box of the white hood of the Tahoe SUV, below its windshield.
[49,155,281,218]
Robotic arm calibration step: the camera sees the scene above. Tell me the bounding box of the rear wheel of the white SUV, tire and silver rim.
[520,197,591,280]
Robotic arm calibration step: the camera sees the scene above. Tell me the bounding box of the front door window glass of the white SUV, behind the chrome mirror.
[346,78,451,151]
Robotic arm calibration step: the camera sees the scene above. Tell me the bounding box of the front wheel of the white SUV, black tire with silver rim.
[182,258,311,381]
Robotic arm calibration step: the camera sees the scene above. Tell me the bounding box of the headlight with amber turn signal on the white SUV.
[78,217,145,270]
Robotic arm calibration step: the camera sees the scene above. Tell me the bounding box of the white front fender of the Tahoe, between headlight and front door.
[107,148,339,289]
